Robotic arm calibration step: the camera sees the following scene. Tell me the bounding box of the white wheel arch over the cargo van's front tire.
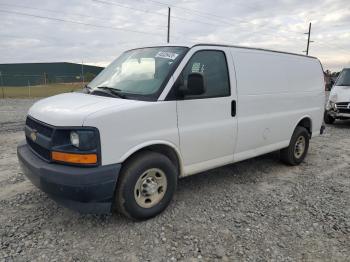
[120,140,183,177]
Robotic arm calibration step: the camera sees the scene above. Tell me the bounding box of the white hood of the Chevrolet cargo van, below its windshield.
[28,93,140,126]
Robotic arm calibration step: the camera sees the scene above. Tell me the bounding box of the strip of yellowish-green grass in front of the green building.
[0,83,83,99]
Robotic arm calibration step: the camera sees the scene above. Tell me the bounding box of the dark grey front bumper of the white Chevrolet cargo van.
[17,142,121,213]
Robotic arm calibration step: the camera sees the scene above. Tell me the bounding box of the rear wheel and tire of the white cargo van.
[280,126,310,166]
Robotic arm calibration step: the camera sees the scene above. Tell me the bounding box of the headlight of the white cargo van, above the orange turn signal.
[70,130,98,150]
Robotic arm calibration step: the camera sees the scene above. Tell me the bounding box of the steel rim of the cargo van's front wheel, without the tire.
[134,168,168,208]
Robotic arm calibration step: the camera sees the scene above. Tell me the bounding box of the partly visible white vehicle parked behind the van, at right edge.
[324,68,350,124]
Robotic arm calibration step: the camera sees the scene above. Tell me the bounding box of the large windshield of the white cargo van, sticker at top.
[88,46,188,100]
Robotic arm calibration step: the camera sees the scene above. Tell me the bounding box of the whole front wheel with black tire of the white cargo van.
[115,151,178,220]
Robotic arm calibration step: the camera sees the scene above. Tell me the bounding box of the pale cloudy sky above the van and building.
[0,0,350,71]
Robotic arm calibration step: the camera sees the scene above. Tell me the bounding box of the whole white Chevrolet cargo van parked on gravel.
[18,44,325,220]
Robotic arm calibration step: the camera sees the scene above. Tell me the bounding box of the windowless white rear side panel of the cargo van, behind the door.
[231,48,325,161]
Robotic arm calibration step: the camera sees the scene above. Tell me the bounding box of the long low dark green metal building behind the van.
[0,62,103,86]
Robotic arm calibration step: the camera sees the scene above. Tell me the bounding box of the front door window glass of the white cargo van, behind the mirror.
[182,50,230,99]
